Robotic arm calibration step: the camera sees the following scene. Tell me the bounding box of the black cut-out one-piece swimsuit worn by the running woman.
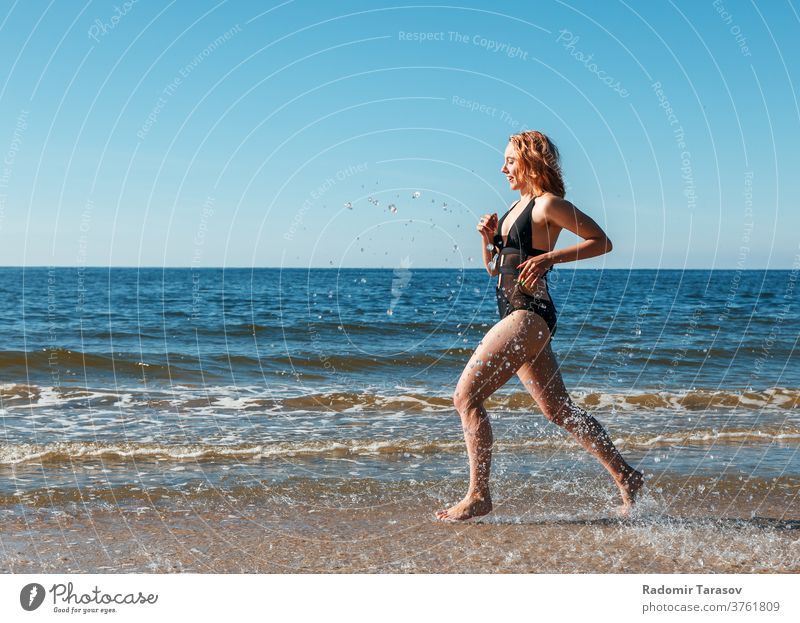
[494,197,557,336]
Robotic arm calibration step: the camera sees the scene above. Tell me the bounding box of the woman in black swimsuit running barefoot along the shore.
[436,131,644,521]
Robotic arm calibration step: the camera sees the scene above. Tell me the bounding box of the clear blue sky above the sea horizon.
[0,0,800,269]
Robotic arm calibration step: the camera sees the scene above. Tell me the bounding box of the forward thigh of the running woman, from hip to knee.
[455,310,550,404]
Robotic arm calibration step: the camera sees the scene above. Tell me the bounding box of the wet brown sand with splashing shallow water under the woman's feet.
[0,477,800,573]
